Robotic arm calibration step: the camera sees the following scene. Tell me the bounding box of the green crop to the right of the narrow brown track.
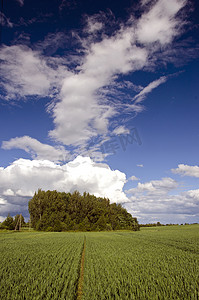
[83,225,199,300]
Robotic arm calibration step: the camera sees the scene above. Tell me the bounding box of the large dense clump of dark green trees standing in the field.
[28,190,139,231]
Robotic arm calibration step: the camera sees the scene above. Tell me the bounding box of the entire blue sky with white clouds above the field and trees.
[0,0,199,224]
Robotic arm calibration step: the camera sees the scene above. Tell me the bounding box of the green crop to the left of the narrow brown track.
[0,233,84,300]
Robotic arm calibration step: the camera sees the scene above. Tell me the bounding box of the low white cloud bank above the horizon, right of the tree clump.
[125,178,199,223]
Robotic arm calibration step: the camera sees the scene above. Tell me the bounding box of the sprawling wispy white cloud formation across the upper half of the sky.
[0,0,186,149]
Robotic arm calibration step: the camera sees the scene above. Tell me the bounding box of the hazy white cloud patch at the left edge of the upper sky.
[0,46,50,98]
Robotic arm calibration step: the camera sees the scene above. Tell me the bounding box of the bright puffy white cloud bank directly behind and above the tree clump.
[0,156,128,215]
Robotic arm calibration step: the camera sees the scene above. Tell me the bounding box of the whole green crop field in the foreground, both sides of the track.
[0,225,199,300]
